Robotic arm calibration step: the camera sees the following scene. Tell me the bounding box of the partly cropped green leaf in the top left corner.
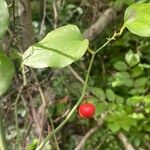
[0,0,9,39]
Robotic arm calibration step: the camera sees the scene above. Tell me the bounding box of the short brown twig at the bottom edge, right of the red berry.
[117,132,135,150]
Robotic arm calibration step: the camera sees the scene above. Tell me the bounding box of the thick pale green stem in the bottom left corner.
[0,113,8,150]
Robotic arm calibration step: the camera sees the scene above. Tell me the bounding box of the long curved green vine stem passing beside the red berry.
[36,25,125,150]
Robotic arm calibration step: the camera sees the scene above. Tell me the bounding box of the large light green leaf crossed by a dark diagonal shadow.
[23,25,89,68]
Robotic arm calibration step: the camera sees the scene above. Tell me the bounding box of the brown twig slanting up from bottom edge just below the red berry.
[74,112,107,150]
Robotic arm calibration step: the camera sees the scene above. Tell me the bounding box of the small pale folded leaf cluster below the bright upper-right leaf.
[125,50,140,67]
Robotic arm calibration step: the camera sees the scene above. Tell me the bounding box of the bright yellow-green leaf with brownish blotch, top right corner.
[124,3,150,37]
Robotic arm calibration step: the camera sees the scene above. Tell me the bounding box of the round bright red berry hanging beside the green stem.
[79,103,95,118]
